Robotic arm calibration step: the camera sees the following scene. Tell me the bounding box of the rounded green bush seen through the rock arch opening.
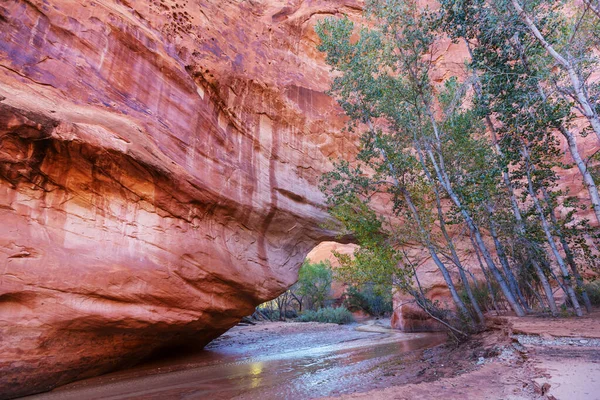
[297,261,333,309]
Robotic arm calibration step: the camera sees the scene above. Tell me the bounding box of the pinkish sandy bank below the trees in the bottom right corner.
[326,311,600,400]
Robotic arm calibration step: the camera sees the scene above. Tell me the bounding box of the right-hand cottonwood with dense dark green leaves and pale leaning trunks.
[442,0,598,314]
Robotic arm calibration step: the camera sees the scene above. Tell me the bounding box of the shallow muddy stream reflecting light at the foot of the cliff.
[24,327,445,400]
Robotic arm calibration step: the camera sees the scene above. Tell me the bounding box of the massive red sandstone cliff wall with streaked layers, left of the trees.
[0,0,360,398]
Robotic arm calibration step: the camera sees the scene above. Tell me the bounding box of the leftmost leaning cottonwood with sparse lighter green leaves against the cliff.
[317,2,512,332]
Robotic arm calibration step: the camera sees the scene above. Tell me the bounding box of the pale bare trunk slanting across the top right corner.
[512,0,600,140]
